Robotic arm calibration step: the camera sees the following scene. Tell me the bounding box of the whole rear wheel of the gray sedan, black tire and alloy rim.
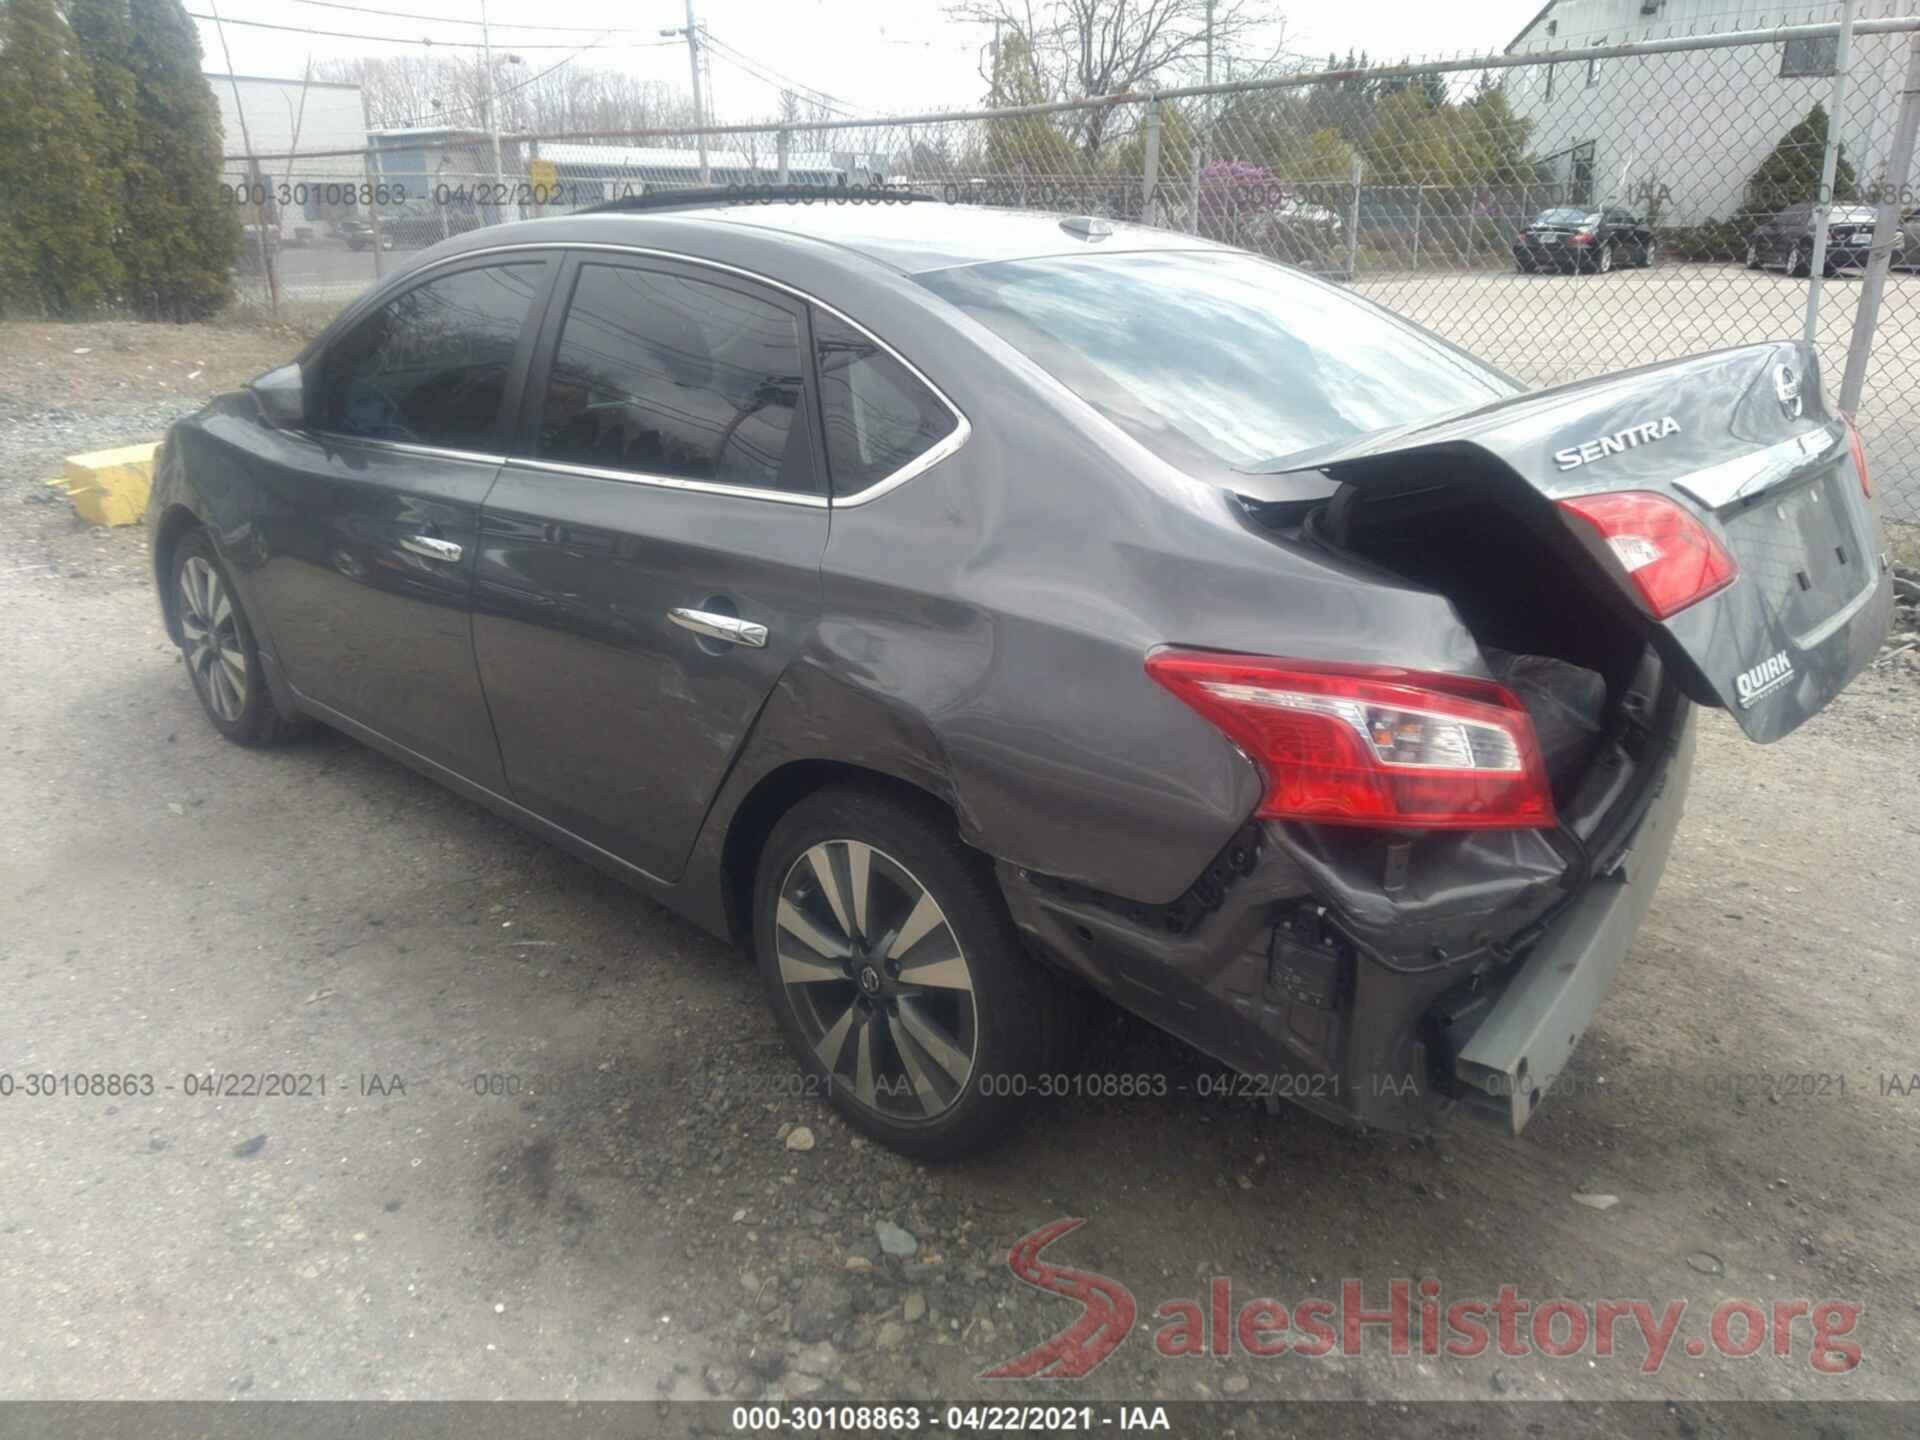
[753,789,1054,1158]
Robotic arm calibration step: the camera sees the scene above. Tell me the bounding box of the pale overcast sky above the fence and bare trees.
[186,0,1540,121]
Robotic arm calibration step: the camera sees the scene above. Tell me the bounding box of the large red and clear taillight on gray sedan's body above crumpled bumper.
[1146,649,1555,829]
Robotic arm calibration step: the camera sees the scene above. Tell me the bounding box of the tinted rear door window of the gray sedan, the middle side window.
[540,265,814,490]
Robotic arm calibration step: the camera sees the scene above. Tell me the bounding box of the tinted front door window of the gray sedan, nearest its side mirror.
[315,261,545,449]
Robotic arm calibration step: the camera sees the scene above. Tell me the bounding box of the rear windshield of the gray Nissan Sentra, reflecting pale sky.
[918,252,1515,472]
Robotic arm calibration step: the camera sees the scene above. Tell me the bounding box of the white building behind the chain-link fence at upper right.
[1505,0,1908,225]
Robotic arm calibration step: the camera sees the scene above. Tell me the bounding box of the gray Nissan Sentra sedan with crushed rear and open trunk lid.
[150,198,1891,1156]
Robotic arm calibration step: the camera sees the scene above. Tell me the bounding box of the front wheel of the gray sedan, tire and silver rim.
[169,530,307,745]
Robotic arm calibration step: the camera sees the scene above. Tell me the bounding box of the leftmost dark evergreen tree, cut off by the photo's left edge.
[0,0,121,315]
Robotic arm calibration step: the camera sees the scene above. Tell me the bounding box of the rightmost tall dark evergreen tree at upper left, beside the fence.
[123,0,240,321]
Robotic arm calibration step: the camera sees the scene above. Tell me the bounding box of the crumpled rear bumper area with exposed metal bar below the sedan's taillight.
[1000,703,1693,1133]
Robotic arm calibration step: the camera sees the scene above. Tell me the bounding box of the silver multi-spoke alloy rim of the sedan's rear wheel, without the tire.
[774,839,979,1121]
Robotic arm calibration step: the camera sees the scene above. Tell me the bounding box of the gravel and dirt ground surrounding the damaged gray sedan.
[11,314,1920,1434]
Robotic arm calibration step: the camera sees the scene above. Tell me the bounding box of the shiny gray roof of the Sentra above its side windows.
[422,200,1225,275]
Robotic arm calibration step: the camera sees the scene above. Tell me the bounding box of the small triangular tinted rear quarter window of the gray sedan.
[814,311,958,495]
